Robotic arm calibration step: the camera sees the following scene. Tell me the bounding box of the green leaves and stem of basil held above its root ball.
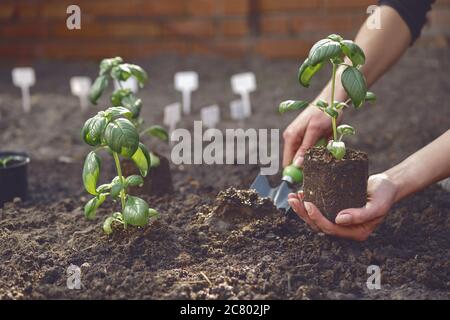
[278,34,376,160]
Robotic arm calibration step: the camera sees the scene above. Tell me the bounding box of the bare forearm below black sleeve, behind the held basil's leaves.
[312,6,411,101]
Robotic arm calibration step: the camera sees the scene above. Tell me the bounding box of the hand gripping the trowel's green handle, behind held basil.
[283,105,342,167]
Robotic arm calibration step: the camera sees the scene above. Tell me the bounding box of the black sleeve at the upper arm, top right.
[378,0,435,43]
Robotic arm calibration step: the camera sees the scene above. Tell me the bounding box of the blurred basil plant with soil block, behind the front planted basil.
[89,57,173,195]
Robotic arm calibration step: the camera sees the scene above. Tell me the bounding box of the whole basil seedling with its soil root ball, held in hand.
[279,34,376,220]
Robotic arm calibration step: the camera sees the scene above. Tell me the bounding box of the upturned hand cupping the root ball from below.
[288,174,397,241]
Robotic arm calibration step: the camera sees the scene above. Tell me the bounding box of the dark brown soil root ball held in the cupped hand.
[303,147,369,221]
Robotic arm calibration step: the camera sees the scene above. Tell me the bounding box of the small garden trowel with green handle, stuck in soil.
[250,165,303,215]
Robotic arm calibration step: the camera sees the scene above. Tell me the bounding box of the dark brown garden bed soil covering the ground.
[0,49,450,299]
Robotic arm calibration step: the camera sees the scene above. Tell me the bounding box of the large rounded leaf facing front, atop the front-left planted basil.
[104,118,139,158]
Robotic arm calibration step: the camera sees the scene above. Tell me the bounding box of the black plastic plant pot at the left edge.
[0,151,30,208]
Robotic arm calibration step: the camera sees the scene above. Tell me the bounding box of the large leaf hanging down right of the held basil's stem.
[341,67,367,108]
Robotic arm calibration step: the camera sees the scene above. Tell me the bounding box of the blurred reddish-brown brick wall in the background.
[0,0,450,60]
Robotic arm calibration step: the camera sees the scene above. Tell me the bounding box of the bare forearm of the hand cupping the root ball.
[384,130,450,202]
